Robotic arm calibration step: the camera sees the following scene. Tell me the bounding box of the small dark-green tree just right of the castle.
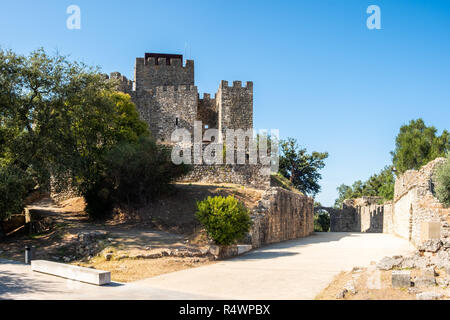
[279,138,328,196]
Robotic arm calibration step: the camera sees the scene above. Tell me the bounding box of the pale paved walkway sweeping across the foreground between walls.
[0,233,413,299]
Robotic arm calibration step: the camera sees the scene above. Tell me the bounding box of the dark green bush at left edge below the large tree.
[0,166,32,221]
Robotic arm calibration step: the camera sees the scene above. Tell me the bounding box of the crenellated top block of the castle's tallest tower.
[134,57,194,91]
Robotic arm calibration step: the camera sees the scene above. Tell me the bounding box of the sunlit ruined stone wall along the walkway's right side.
[330,158,450,245]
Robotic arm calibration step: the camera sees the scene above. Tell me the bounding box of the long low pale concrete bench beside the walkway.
[31,260,111,286]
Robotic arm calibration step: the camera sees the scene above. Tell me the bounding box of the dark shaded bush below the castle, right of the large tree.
[83,137,189,218]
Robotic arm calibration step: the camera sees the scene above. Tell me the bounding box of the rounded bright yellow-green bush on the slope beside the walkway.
[195,196,252,245]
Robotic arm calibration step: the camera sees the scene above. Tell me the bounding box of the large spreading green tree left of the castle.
[0,49,156,218]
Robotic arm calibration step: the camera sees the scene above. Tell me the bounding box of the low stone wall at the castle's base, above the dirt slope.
[180,164,270,189]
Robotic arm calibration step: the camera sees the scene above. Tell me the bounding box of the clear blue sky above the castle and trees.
[0,0,450,205]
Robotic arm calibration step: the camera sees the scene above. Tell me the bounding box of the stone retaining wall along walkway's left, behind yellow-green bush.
[249,187,314,248]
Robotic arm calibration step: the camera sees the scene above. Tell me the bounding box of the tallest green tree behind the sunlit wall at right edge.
[391,119,450,173]
